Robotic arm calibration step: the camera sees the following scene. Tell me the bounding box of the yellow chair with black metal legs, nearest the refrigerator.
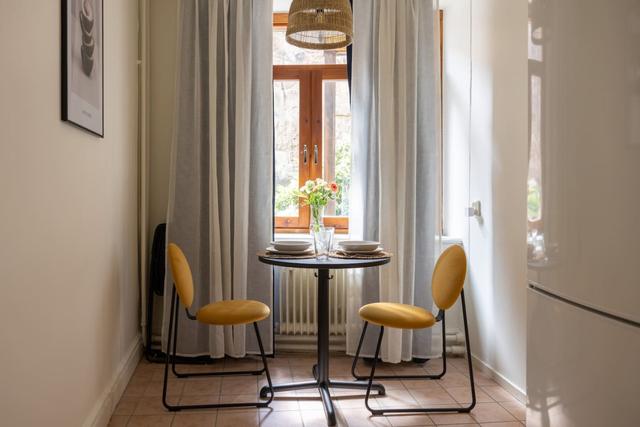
[351,245,476,415]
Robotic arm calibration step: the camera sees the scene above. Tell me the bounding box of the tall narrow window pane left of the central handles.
[273,80,300,216]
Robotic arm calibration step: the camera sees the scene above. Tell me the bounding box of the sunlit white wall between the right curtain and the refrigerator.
[441,0,527,391]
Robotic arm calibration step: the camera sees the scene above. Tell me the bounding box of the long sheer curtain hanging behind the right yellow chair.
[347,0,442,362]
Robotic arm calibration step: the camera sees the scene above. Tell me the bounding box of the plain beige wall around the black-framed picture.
[0,0,139,426]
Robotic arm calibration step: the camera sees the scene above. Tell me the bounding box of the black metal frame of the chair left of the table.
[162,284,274,411]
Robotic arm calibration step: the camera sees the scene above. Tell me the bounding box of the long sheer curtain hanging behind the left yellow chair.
[163,0,273,357]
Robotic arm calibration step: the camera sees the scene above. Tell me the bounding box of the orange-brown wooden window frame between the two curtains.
[273,13,349,234]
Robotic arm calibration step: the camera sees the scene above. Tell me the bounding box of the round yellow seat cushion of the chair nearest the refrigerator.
[359,302,436,329]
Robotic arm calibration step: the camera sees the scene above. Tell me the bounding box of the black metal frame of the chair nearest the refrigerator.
[351,290,476,415]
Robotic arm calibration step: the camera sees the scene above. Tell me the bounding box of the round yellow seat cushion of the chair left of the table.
[196,300,271,325]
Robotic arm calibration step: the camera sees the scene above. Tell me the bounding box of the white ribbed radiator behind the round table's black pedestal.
[278,269,349,336]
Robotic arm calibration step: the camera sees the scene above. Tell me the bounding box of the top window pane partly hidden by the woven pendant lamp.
[273,28,347,65]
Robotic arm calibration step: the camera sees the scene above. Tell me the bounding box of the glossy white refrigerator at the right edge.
[527,0,640,427]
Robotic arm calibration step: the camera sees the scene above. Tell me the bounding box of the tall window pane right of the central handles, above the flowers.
[322,80,351,216]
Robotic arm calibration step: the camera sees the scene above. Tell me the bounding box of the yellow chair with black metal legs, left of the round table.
[162,243,273,411]
